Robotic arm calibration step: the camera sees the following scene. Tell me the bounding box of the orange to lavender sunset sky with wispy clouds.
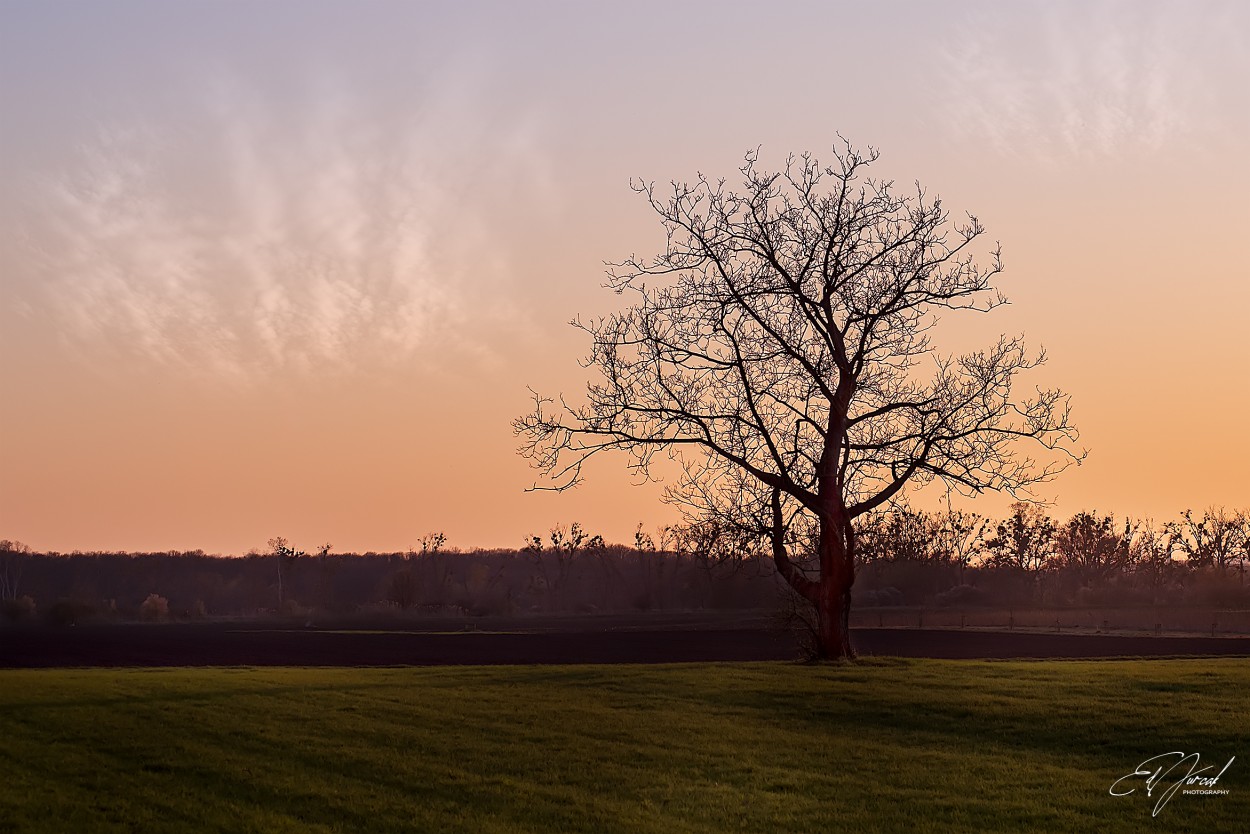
[0,0,1250,554]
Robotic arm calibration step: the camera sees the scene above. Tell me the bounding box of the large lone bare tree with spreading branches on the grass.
[514,144,1084,658]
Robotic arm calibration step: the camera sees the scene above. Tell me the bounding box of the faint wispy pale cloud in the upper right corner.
[940,3,1250,161]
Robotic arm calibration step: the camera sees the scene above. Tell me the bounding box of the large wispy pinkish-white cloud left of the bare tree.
[9,70,550,380]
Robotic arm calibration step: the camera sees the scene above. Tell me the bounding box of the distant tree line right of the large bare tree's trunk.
[855,503,1250,608]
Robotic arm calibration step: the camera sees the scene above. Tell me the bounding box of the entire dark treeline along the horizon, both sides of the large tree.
[0,504,1250,624]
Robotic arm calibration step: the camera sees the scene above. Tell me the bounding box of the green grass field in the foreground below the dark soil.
[0,659,1250,834]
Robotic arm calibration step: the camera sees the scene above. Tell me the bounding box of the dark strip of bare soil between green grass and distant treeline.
[0,615,1250,668]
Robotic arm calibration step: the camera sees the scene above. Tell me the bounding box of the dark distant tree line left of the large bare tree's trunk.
[0,524,776,624]
